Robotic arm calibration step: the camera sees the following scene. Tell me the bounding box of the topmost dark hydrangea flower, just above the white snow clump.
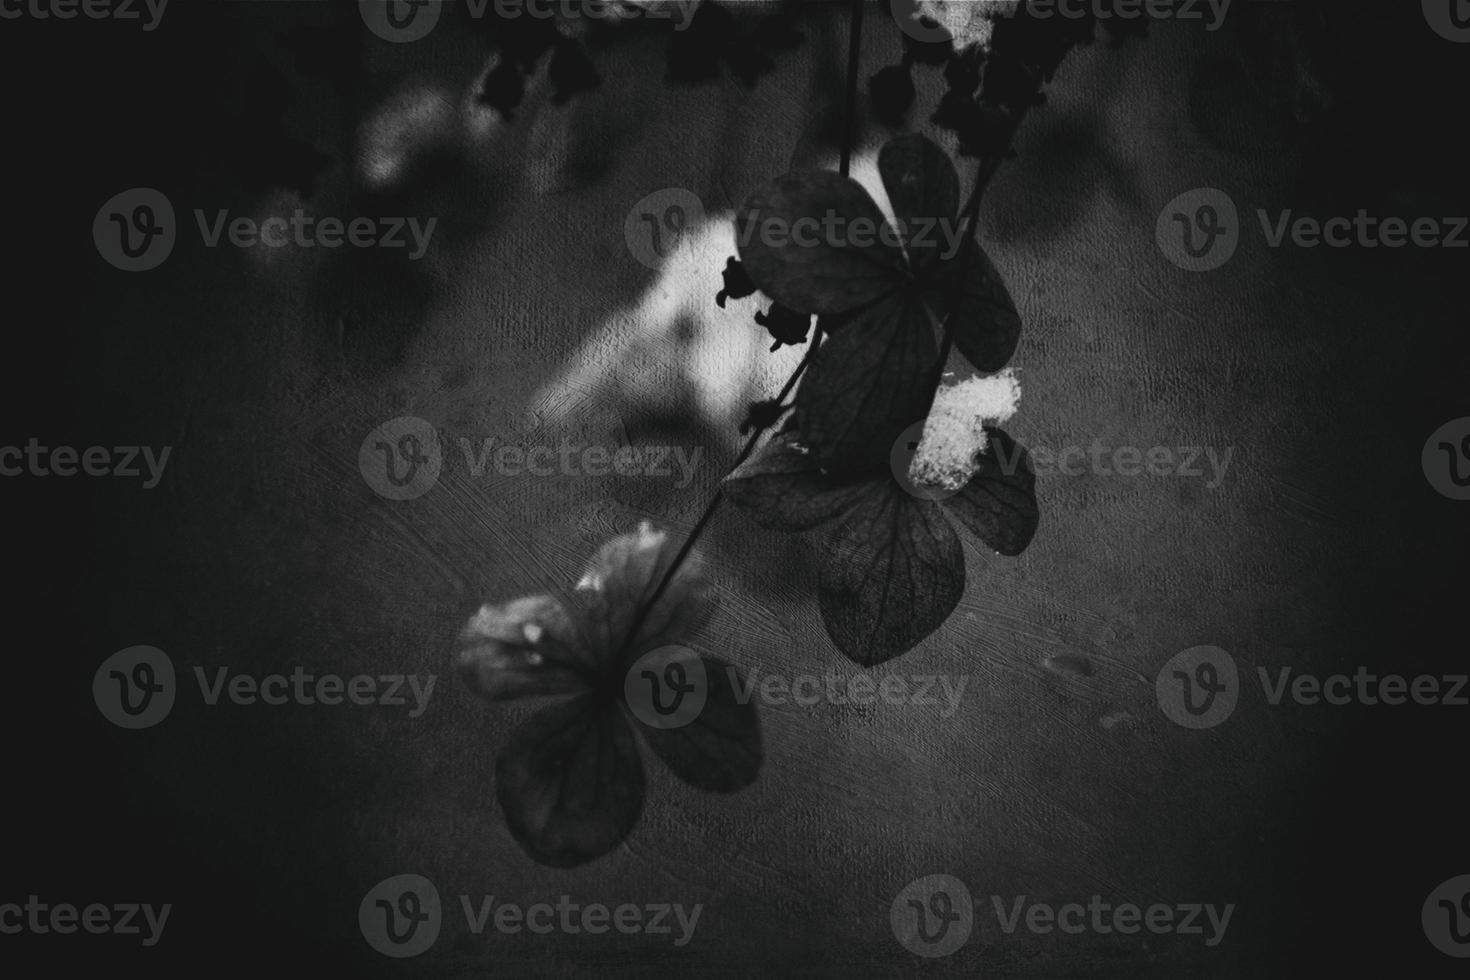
[736,134,1020,473]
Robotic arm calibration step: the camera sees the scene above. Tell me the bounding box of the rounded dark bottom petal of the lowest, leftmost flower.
[495,695,644,868]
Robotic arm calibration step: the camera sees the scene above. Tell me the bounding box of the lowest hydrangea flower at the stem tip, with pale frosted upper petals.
[456,523,763,867]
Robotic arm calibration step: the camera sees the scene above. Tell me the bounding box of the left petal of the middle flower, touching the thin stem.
[725,432,863,530]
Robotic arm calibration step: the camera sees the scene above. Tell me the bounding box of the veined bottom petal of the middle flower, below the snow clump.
[817,476,964,667]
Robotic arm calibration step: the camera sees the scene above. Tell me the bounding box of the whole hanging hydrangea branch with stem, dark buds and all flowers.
[457,0,1123,867]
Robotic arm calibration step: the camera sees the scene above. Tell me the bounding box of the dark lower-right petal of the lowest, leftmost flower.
[637,657,764,793]
